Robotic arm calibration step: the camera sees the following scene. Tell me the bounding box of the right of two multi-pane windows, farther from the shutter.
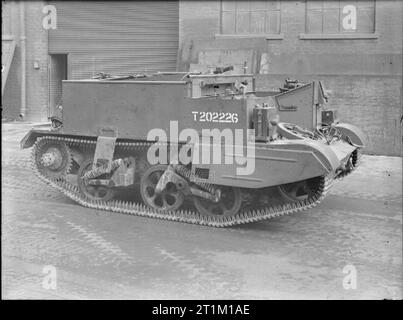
[306,0,375,34]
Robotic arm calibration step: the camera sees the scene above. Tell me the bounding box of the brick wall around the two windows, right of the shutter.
[178,0,403,155]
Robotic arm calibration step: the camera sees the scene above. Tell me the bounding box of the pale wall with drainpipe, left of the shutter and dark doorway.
[2,1,48,121]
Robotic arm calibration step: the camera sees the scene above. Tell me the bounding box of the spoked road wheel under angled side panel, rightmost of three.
[193,186,242,216]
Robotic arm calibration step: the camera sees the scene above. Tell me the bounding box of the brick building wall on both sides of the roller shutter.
[2,0,403,155]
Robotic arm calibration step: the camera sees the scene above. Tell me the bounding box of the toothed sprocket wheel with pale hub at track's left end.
[34,140,72,179]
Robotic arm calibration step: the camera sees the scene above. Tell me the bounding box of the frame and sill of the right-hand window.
[299,0,379,40]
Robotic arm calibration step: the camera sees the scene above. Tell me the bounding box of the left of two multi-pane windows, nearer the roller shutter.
[221,0,280,35]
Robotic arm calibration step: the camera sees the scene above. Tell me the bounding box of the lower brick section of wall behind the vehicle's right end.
[257,75,401,155]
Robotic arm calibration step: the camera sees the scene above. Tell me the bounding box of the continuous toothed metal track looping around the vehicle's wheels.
[31,136,360,227]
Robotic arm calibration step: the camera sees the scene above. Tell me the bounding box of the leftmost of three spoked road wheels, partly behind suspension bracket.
[77,159,115,201]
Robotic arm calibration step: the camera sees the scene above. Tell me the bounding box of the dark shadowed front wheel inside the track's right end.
[278,178,319,202]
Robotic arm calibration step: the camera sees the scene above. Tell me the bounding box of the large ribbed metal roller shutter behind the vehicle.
[49,1,179,79]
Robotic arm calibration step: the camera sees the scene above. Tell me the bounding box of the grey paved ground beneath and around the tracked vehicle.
[2,124,402,299]
